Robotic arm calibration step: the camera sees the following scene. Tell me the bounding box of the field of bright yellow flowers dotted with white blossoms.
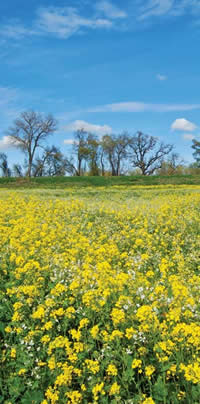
[0,186,200,404]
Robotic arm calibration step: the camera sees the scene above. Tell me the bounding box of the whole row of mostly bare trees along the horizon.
[0,111,200,177]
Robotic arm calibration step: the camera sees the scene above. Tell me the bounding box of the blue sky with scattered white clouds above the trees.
[0,0,200,167]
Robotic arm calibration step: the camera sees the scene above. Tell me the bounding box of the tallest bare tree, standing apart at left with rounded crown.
[7,111,56,177]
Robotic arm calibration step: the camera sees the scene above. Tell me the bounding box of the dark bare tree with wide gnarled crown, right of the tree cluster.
[129,132,173,175]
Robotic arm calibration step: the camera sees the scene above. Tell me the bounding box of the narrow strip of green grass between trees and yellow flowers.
[0,175,200,188]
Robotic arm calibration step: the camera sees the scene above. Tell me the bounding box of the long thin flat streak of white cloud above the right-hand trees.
[87,101,200,112]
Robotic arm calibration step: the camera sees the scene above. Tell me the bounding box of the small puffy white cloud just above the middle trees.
[63,120,112,136]
